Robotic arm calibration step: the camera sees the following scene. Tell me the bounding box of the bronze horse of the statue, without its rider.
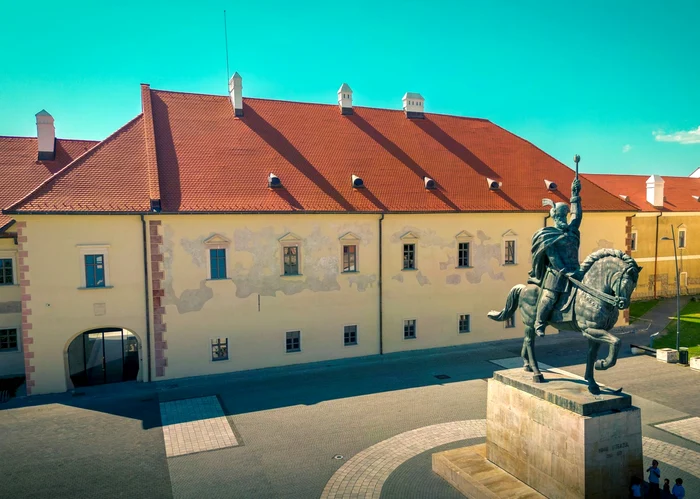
[488,249,642,395]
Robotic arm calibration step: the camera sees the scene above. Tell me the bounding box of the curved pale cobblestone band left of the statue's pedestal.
[321,419,486,499]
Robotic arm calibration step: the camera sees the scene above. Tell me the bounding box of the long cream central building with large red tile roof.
[0,78,639,393]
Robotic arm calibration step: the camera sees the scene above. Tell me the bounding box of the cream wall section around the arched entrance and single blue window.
[17,215,146,394]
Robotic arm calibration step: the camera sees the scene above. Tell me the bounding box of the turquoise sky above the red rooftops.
[0,0,700,176]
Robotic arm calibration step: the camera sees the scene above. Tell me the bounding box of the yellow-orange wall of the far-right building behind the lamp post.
[631,213,700,299]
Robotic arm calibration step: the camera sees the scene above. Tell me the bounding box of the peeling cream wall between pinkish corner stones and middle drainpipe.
[160,214,379,378]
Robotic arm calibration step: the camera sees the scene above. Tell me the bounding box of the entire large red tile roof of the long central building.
[5,85,634,217]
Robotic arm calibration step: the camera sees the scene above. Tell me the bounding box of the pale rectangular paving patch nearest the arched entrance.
[160,397,238,457]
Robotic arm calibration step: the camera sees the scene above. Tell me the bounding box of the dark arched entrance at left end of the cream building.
[68,328,139,387]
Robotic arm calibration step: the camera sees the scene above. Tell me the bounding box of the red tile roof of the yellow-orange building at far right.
[585,173,700,212]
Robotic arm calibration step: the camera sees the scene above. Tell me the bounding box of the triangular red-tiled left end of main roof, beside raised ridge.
[8,115,150,213]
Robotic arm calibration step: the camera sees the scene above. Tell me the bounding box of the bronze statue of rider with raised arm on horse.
[488,155,642,395]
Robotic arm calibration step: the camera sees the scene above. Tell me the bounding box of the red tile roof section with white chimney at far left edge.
[0,137,98,230]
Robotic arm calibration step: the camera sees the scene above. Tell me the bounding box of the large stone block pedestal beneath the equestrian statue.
[433,369,643,499]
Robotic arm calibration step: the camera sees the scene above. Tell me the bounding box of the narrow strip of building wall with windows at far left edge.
[0,237,24,376]
